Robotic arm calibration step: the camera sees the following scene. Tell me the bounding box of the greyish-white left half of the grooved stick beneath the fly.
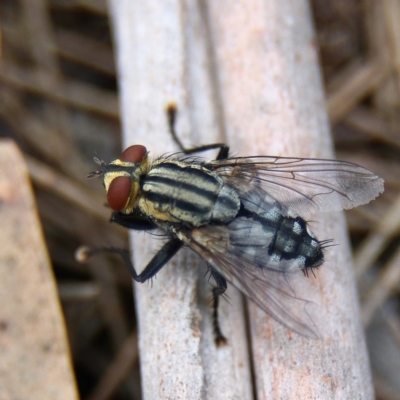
[111,0,252,399]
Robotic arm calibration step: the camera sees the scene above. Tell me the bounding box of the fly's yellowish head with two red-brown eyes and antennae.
[88,145,149,214]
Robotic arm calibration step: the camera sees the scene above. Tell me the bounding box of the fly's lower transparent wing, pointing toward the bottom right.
[178,217,320,338]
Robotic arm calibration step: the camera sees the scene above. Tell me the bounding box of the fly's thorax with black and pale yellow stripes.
[139,159,240,227]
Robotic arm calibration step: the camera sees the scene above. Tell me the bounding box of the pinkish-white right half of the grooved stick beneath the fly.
[206,0,373,399]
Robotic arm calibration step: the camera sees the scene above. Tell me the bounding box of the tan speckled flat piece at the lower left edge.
[0,140,78,400]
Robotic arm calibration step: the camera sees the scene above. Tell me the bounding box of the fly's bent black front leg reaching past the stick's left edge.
[75,239,183,283]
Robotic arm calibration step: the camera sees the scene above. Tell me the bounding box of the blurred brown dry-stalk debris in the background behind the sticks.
[0,0,400,400]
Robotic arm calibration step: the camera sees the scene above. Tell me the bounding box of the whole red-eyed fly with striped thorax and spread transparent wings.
[76,106,384,344]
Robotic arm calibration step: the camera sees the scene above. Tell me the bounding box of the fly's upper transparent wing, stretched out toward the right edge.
[208,157,384,216]
